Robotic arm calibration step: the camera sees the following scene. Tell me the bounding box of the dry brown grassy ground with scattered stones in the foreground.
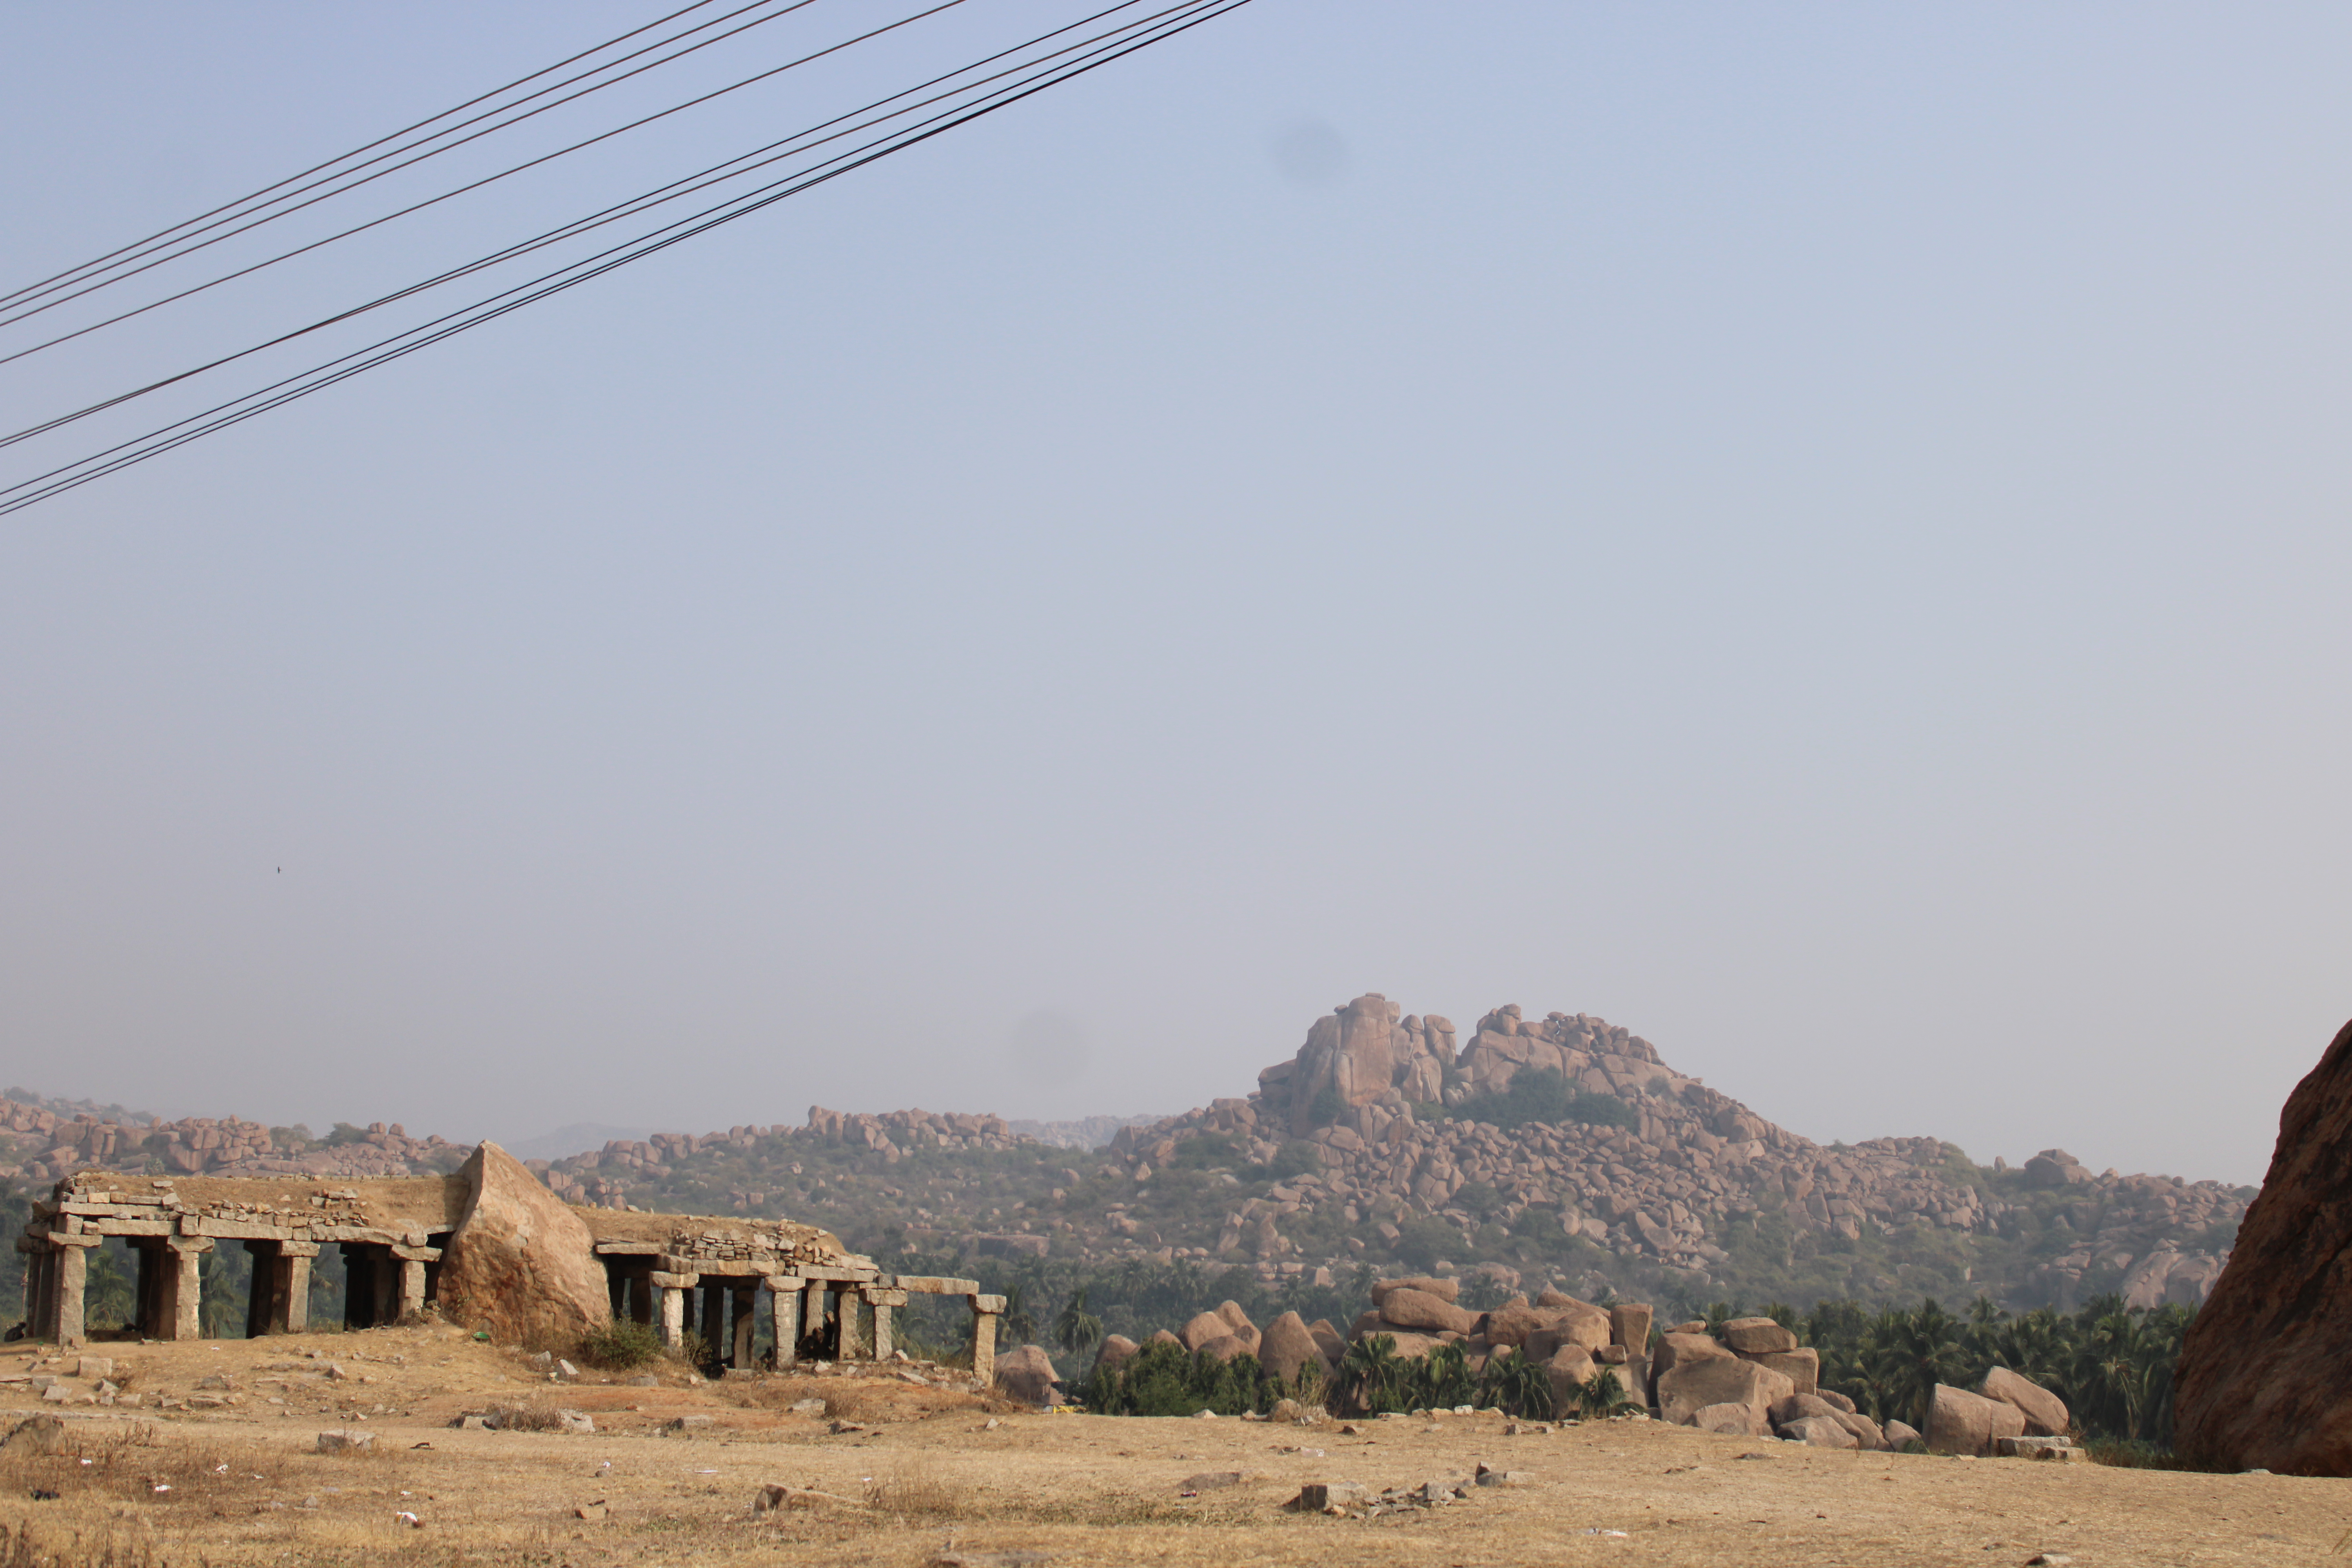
[0,1328,2352,1568]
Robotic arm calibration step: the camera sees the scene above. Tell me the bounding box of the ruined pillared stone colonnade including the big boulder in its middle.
[16,1143,1004,1380]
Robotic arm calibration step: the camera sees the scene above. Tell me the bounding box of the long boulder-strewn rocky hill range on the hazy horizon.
[0,995,2253,1307]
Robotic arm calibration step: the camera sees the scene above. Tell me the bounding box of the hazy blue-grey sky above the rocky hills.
[0,0,2352,1180]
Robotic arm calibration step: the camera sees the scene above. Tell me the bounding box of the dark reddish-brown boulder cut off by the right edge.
[2173,1023,2352,1476]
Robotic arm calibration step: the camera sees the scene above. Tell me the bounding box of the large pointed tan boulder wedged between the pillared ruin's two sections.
[440,1143,612,1345]
